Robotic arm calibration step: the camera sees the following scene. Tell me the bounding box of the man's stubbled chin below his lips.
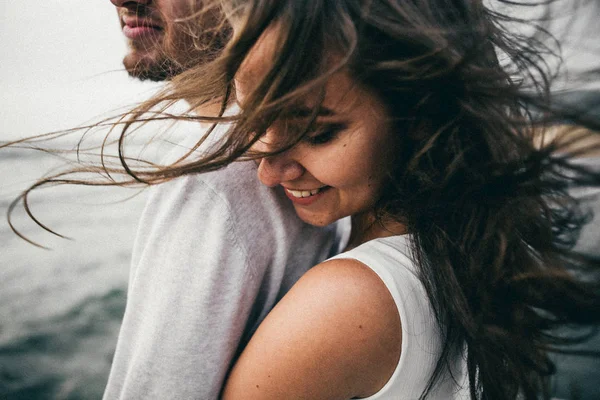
[123,52,181,82]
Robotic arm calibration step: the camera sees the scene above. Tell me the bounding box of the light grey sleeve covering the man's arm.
[104,175,268,400]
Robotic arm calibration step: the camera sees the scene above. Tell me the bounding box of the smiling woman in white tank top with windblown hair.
[8,0,600,399]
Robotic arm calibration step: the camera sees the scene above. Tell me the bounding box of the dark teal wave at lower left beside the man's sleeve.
[0,288,125,400]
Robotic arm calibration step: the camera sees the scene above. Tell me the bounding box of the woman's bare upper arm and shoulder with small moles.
[223,259,401,400]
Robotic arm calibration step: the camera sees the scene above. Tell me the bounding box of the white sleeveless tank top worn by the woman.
[333,235,470,400]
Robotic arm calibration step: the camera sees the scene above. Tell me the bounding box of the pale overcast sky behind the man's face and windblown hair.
[0,0,600,140]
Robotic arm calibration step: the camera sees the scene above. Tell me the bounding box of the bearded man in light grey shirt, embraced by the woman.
[104,0,345,400]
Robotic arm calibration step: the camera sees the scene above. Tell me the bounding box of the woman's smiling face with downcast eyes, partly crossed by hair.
[236,32,394,226]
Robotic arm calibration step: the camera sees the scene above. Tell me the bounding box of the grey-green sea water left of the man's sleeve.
[0,150,144,400]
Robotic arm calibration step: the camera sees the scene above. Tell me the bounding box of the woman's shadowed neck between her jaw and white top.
[345,211,408,251]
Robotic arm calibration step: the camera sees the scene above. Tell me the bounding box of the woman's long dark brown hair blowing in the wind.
[3,0,600,400]
